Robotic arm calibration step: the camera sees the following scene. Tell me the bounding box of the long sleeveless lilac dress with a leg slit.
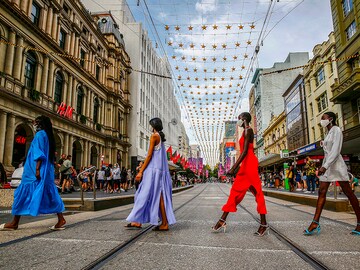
[126,138,176,225]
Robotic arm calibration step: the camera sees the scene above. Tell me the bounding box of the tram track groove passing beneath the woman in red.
[217,184,331,270]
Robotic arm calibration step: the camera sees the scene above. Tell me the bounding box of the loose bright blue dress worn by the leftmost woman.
[12,130,65,216]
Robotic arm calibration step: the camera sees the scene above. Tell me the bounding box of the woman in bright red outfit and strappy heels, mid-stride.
[213,112,269,236]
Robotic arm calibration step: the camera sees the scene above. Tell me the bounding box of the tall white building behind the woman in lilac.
[82,0,188,169]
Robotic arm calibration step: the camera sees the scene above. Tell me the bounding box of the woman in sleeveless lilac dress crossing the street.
[126,118,176,231]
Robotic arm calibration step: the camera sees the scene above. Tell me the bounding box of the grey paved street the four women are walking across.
[0,183,360,269]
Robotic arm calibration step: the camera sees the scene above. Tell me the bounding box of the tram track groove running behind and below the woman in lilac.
[81,185,207,270]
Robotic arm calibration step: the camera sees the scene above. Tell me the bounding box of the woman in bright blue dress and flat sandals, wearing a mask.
[0,116,66,230]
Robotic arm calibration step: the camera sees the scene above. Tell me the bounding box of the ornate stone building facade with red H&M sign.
[0,0,131,170]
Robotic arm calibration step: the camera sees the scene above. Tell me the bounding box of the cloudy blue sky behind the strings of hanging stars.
[81,0,333,163]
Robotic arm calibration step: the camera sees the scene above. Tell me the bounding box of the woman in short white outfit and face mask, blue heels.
[304,112,360,235]
